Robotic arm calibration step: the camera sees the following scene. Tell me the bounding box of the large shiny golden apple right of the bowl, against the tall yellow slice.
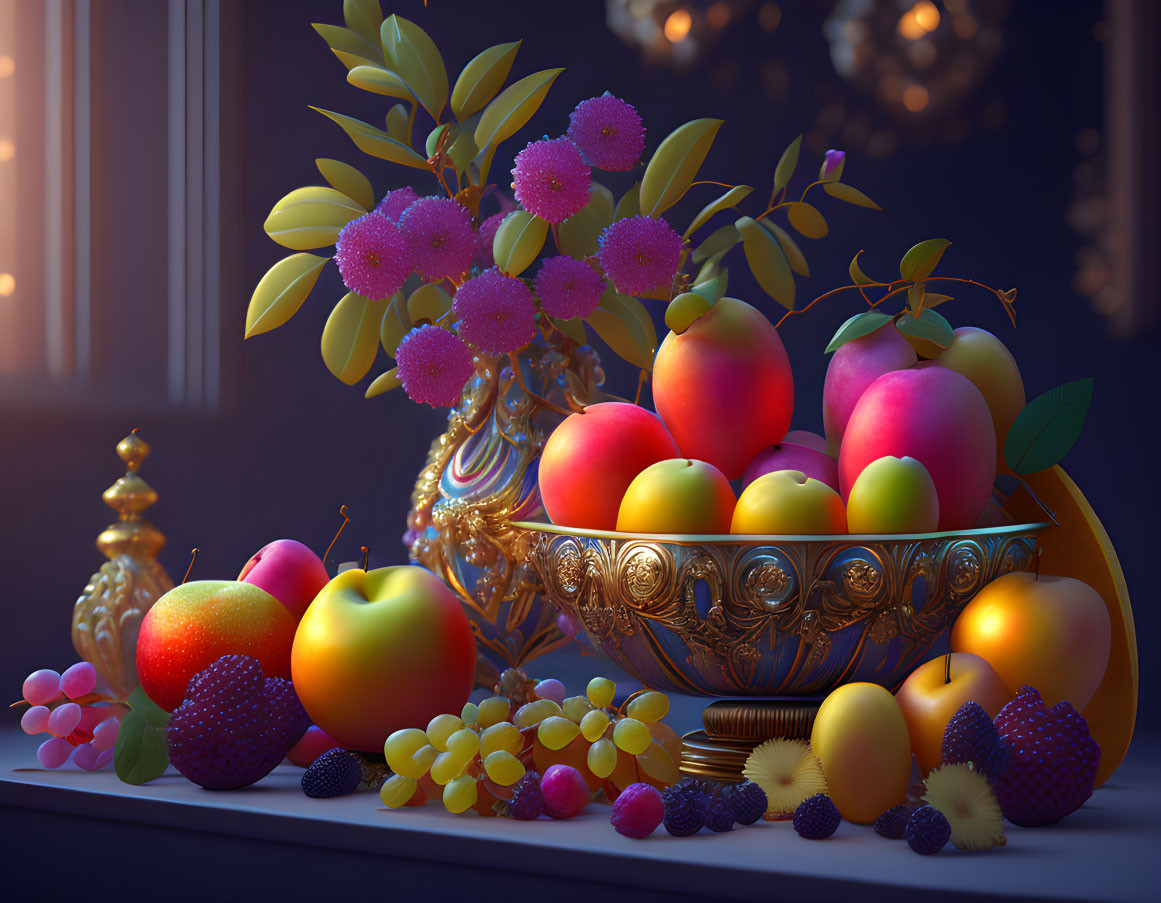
[951,571,1112,711]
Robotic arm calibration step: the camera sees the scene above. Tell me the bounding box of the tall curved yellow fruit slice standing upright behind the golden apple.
[1005,465,1138,787]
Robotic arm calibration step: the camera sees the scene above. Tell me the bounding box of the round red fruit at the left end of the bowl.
[539,402,679,530]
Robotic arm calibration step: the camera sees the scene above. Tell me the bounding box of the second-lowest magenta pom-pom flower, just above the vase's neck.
[453,267,536,354]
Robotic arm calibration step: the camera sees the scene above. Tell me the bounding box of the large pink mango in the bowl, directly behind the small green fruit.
[838,367,996,530]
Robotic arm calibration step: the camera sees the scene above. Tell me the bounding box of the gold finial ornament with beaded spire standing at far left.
[72,429,173,699]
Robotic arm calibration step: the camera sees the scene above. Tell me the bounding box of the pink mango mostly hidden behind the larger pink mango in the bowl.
[822,323,918,455]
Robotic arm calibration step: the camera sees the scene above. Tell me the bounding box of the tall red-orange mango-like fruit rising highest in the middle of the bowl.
[652,298,794,479]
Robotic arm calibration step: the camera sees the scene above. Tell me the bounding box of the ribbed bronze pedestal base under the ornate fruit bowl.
[680,696,822,783]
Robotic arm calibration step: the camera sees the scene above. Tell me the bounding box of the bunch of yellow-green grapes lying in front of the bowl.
[380,678,679,812]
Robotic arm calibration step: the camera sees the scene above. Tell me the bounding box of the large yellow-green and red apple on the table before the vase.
[290,565,476,752]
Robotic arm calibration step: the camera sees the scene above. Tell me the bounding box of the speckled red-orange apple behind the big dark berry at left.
[137,580,295,711]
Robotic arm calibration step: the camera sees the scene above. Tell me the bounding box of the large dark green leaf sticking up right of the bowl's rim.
[1004,378,1093,474]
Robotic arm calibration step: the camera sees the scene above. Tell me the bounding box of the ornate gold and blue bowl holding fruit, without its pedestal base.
[514,506,1051,696]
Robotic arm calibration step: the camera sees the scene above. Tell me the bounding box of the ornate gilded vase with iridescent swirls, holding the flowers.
[404,333,612,686]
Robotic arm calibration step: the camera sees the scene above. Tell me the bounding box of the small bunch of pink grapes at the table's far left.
[20,662,121,772]
